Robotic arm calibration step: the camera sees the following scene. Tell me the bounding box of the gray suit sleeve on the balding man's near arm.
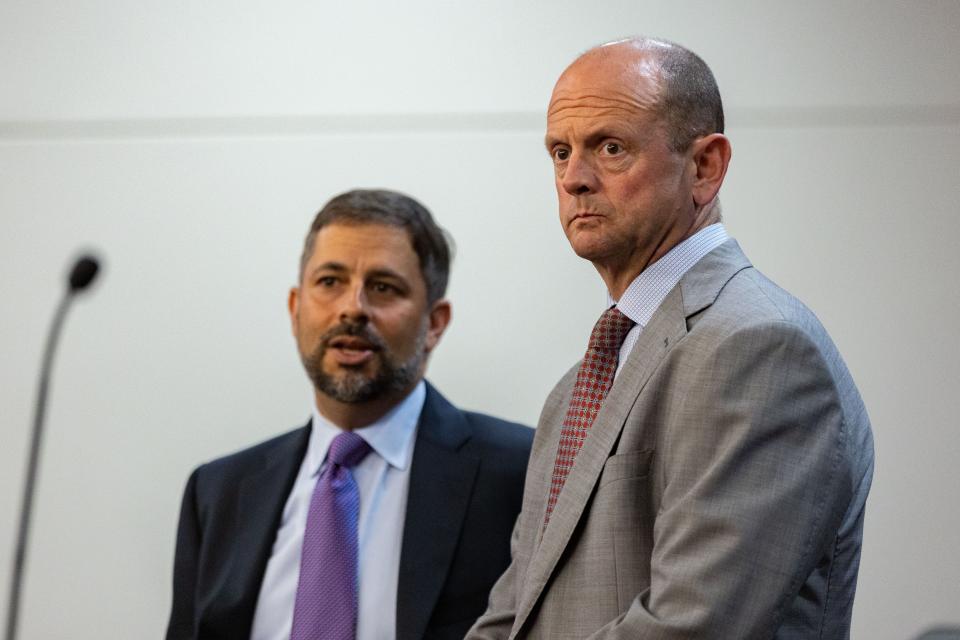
[592,322,851,640]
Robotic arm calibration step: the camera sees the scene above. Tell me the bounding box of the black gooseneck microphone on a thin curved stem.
[4,255,100,640]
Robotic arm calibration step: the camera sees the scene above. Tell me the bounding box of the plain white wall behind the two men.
[0,0,960,640]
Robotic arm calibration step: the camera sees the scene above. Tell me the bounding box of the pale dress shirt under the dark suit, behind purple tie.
[250,381,427,640]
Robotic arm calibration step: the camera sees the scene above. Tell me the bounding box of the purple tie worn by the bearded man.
[290,431,370,640]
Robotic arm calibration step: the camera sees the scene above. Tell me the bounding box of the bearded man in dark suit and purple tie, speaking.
[167,191,533,640]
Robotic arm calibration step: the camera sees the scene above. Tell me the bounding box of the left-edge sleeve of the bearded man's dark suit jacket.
[166,469,200,640]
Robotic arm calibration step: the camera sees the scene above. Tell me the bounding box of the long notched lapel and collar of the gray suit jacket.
[513,240,750,632]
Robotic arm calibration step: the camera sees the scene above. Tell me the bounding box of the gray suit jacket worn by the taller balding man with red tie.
[467,240,873,640]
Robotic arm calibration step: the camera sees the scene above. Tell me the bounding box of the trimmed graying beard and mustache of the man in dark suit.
[301,325,426,404]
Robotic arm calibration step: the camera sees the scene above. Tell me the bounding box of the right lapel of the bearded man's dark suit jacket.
[397,384,479,640]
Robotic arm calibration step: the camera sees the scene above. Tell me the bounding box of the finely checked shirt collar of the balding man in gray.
[607,222,730,327]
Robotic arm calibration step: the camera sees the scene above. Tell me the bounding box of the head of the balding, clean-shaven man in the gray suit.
[544,39,730,299]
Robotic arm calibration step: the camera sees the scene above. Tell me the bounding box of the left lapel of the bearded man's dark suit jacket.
[224,424,310,634]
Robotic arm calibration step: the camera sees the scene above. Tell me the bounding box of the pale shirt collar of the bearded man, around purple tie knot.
[305,380,427,476]
